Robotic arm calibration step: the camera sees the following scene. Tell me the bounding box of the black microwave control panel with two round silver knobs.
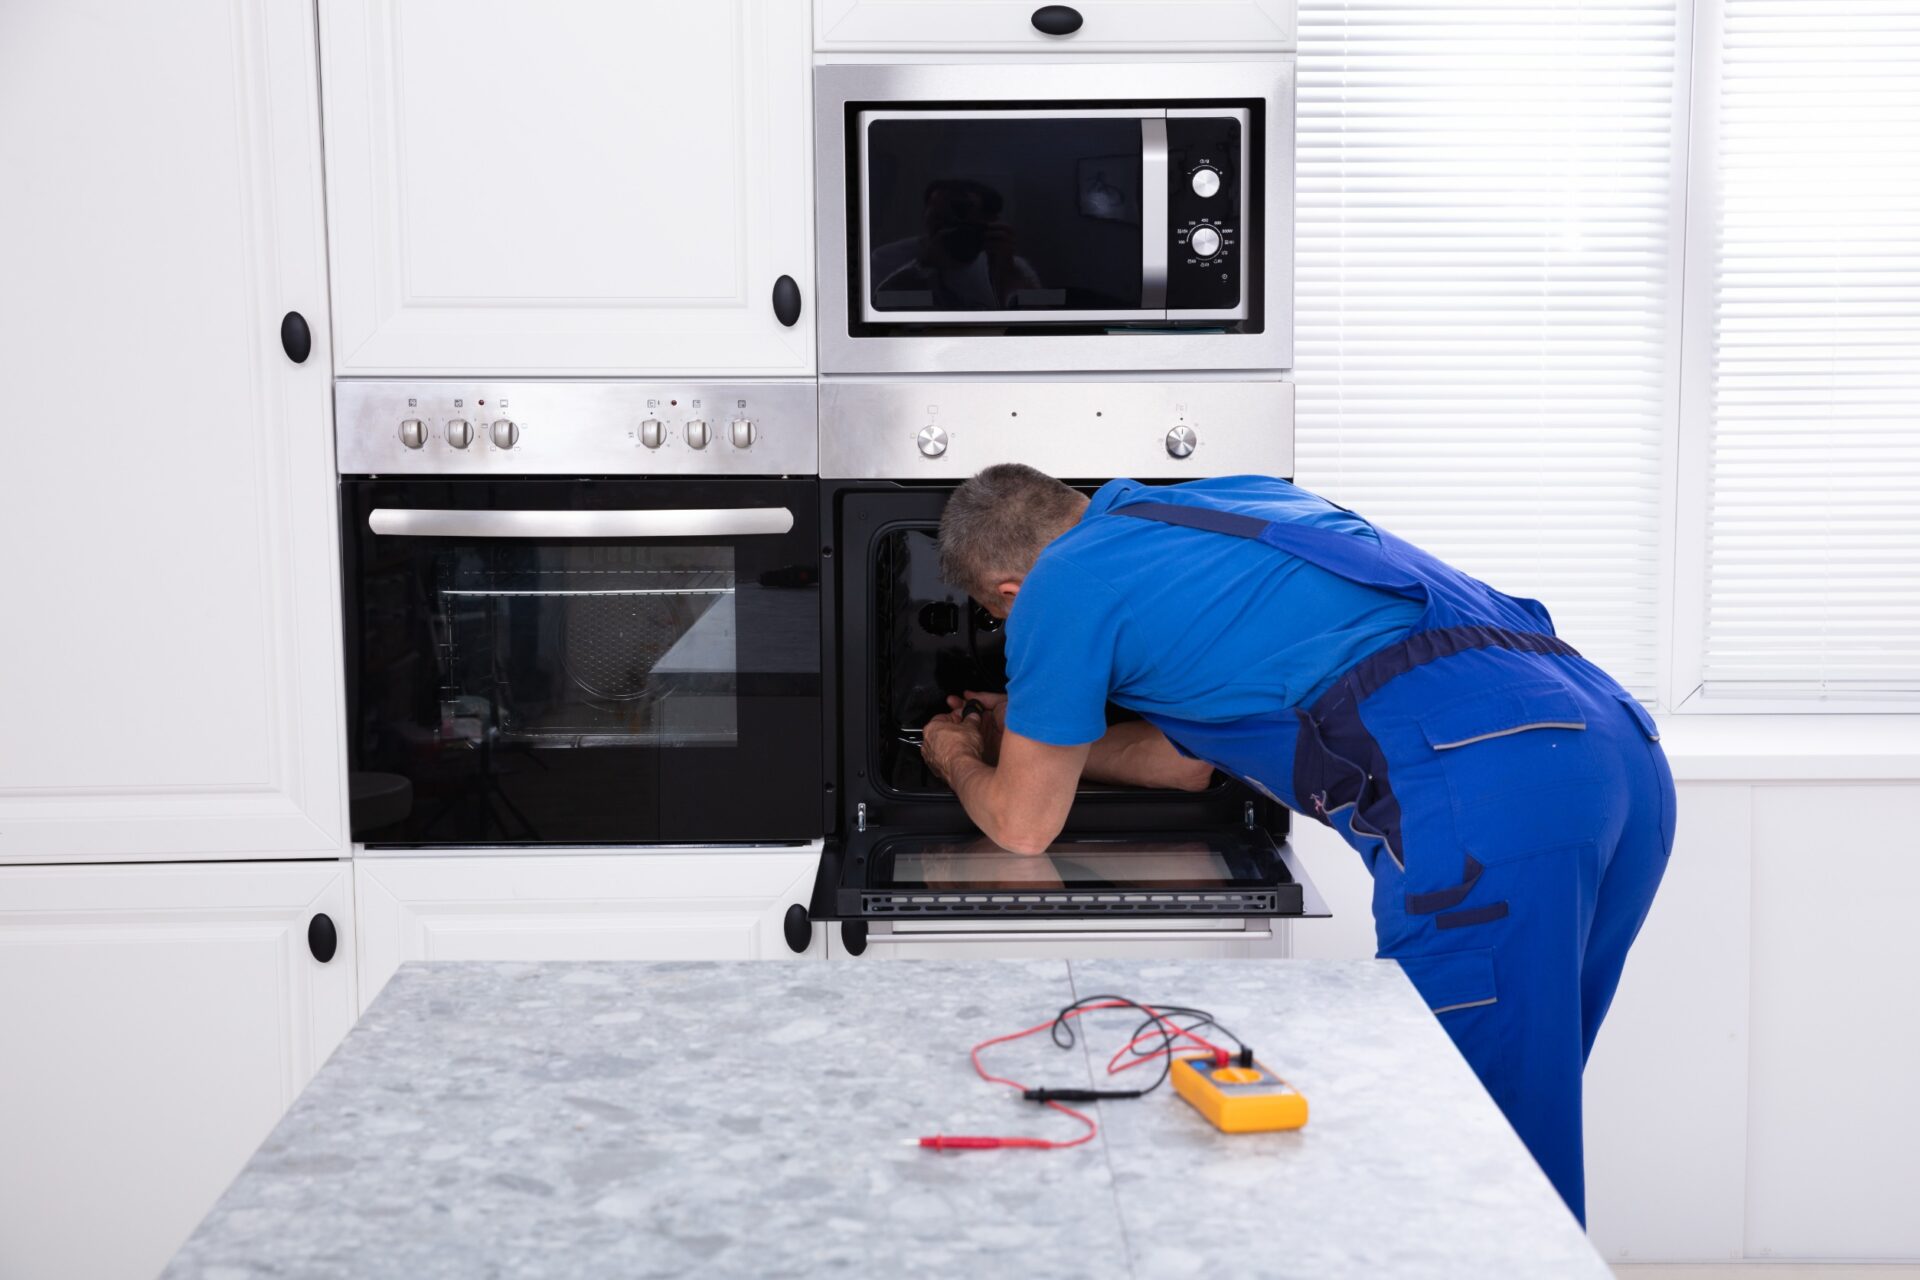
[1167,111,1246,313]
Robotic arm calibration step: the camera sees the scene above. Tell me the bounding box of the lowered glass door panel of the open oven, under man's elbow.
[851,829,1302,915]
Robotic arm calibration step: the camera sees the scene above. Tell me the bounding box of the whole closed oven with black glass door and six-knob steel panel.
[336,382,822,846]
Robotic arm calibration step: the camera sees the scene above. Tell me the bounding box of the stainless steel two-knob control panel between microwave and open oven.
[820,378,1294,480]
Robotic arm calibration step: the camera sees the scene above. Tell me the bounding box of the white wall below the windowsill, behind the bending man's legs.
[1292,744,1920,1261]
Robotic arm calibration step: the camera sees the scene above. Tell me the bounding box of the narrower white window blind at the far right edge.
[1703,0,1920,693]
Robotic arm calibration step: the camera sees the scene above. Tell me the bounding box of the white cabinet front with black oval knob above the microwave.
[814,0,1296,54]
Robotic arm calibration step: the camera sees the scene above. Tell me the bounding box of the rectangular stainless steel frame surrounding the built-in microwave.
[814,54,1294,376]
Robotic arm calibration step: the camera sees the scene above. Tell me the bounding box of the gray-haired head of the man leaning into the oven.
[941,462,1085,599]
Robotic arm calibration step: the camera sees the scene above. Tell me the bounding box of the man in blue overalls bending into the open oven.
[924,464,1674,1221]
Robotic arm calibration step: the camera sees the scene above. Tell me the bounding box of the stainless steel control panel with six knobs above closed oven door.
[334,378,820,476]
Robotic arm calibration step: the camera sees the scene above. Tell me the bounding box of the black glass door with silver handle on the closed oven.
[344,480,820,844]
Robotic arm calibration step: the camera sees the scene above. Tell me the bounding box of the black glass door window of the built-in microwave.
[864,117,1142,313]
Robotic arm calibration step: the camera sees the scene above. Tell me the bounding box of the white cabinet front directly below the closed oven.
[353,848,826,1000]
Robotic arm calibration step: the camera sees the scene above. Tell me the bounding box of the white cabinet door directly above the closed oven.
[321,0,814,374]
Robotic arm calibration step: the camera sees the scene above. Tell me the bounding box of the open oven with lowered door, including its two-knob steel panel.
[812,380,1325,954]
